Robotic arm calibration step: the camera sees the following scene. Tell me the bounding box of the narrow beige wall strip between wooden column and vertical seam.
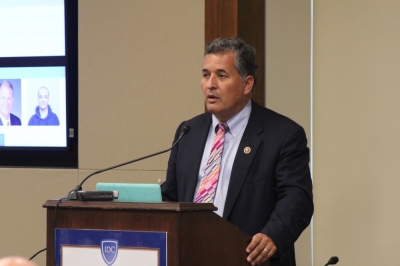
[266,0,312,265]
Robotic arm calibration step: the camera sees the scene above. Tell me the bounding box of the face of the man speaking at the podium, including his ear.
[201,52,254,122]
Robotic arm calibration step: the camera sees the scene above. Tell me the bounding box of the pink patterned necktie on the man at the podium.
[194,123,228,203]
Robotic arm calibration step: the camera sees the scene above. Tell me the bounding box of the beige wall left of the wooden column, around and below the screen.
[0,0,204,265]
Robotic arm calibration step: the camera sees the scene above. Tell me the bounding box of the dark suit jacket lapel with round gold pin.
[223,103,263,219]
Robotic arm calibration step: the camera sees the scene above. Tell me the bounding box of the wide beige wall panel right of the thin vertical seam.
[313,0,400,265]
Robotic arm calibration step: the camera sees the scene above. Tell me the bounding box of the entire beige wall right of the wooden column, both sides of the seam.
[266,0,400,265]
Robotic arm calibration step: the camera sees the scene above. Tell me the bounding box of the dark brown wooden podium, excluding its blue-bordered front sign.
[43,200,269,266]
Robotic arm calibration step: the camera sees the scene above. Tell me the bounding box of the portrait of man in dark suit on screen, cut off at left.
[0,78,21,126]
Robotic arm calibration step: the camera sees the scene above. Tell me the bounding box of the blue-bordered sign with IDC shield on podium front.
[55,228,167,266]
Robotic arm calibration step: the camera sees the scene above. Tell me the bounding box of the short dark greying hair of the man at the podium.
[204,37,258,84]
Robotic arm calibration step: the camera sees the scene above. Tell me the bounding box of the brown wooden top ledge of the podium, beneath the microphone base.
[43,199,217,212]
